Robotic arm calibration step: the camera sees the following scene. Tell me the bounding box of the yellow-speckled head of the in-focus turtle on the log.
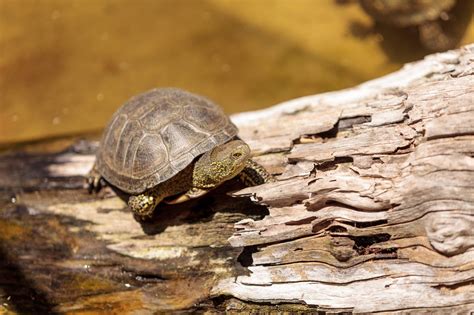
[193,140,250,189]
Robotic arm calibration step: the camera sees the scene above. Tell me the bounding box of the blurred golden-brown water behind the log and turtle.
[0,0,474,145]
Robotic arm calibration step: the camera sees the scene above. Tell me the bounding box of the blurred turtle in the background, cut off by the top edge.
[359,0,457,51]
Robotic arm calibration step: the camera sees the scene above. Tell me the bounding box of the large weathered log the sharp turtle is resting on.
[0,45,474,314]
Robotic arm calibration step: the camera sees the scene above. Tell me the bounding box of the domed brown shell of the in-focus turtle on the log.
[96,88,237,194]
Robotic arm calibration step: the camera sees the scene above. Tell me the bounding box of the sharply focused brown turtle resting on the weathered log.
[87,88,274,219]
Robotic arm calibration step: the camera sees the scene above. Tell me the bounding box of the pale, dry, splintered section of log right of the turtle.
[213,46,474,312]
